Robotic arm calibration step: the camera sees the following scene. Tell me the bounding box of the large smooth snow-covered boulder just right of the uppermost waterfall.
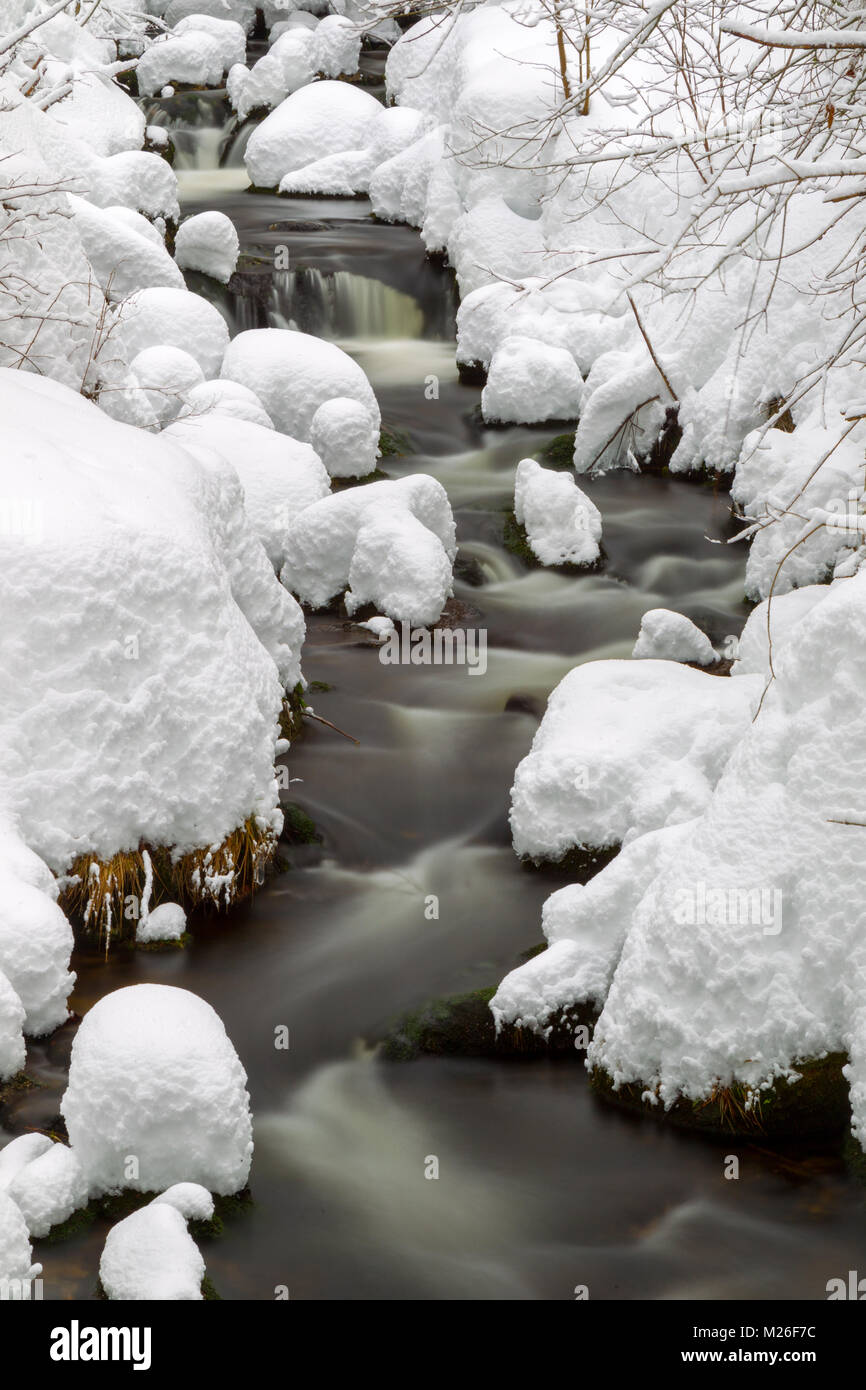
[245,77,382,188]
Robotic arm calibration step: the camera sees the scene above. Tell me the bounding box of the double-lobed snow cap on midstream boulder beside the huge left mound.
[281,474,456,624]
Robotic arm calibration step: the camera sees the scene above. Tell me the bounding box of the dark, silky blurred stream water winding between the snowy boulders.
[8,59,866,1300]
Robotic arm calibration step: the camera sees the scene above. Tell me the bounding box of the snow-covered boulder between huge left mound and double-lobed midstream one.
[167,414,331,570]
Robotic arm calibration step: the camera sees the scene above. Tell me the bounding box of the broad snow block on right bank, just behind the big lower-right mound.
[510,660,763,859]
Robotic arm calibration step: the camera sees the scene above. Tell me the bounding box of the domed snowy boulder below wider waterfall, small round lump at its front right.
[221,328,381,443]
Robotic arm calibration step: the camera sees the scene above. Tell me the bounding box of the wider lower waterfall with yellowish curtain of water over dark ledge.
[268,270,424,341]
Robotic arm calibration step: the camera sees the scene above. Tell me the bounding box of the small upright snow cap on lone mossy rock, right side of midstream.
[514,459,602,564]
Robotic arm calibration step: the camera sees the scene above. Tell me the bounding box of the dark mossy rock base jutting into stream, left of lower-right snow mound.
[379,988,585,1062]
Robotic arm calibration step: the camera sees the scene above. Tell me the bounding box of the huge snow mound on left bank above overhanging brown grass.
[0,371,303,884]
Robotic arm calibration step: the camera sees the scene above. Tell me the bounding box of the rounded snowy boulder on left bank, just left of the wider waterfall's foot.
[113,285,228,378]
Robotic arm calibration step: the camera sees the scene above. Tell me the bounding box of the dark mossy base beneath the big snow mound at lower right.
[589,1052,849,1138]
